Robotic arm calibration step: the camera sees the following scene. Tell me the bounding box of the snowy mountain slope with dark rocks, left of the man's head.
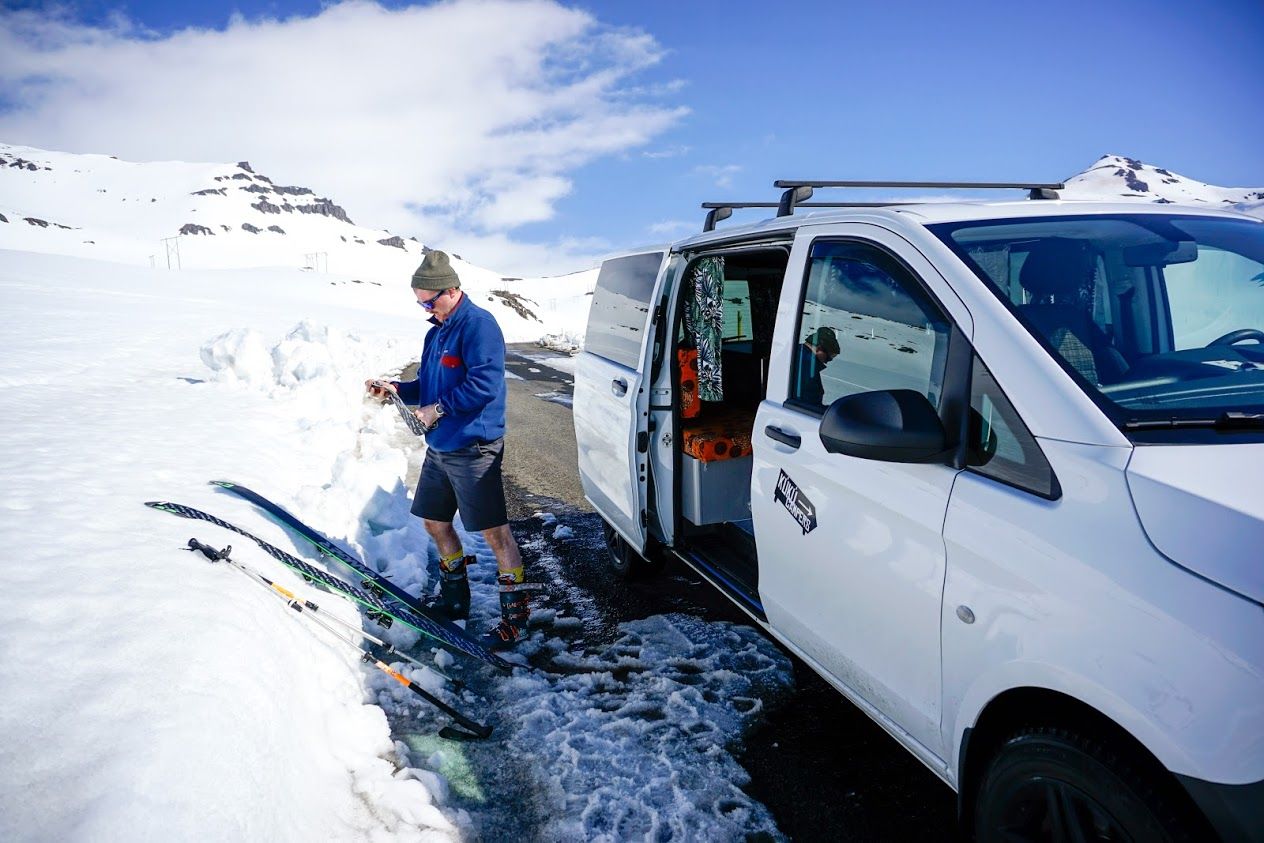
[0,144,425,277]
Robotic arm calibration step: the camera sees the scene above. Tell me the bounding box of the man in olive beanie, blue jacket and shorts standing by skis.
[365,250,530,650]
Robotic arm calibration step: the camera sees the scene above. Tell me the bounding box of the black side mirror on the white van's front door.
[820,389,949,463]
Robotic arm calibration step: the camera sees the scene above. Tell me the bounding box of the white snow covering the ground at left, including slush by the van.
[0,189,791,840]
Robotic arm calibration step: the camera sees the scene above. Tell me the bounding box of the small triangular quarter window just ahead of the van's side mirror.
[966,354,1060,499]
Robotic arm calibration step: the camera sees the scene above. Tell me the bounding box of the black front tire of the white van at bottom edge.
[975,727,1196,843]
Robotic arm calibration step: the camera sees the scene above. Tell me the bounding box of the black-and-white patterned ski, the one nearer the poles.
[145,500,513,672]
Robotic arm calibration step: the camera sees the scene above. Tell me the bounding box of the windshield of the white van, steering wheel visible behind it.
[929,214,1264,431]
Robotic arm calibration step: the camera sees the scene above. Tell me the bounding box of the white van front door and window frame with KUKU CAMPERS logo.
[751,224,972,757]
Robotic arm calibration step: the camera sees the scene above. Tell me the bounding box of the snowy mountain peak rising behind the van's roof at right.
[1062,155,1264,212]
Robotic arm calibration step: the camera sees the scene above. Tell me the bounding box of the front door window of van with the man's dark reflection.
[790,241,951,413]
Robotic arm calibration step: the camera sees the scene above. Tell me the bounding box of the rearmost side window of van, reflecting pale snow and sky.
[584,252,662,369]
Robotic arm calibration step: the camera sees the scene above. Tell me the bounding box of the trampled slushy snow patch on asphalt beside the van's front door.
[501,616,794,840]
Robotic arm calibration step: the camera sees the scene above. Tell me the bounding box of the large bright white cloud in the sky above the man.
[0,0,684,274]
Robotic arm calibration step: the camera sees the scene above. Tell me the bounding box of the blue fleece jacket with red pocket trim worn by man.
[398,294,506,452]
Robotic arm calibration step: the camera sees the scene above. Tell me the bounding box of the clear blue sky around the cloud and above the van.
[0,0,1264,270]
